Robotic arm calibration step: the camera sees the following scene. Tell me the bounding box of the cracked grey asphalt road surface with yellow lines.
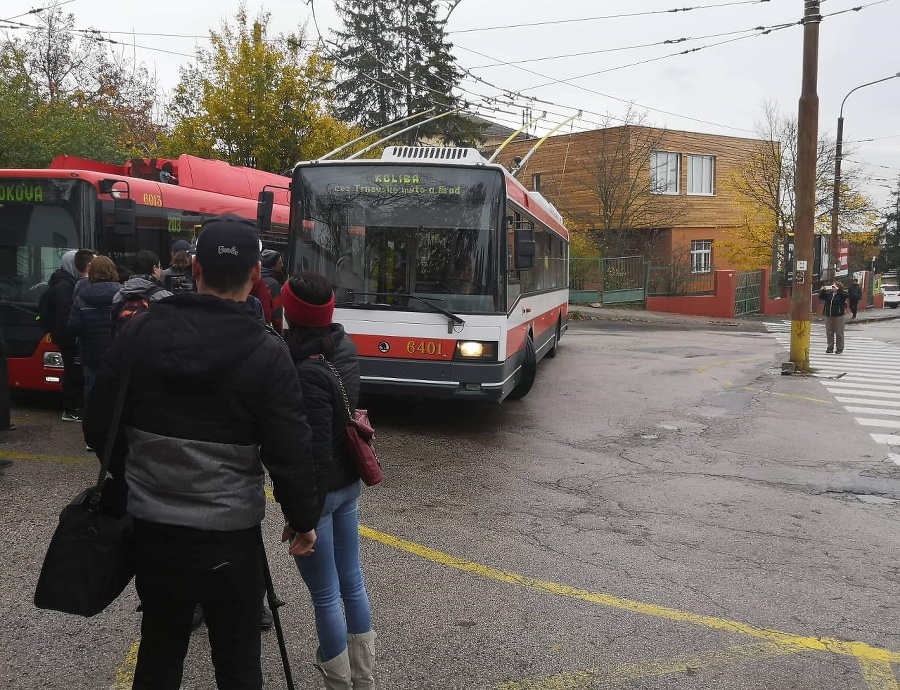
[0,322,900,690]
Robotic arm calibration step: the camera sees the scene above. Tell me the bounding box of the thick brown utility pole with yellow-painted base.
[791,0,822,371]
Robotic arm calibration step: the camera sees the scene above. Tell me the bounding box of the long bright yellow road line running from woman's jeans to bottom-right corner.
[359,525,900,690]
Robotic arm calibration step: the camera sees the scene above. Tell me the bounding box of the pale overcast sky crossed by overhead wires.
[0,0,900,210]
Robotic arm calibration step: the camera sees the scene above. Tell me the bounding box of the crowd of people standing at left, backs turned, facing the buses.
[32,216,375,690]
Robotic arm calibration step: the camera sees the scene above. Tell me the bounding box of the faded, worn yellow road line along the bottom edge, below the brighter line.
[497,642,809,690]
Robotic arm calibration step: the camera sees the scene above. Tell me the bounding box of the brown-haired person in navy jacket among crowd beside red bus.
[69,256,122,400]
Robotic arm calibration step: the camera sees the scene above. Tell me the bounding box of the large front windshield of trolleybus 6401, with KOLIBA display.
[291,163,505,313]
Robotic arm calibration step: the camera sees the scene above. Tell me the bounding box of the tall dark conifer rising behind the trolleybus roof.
[336,0,479,145]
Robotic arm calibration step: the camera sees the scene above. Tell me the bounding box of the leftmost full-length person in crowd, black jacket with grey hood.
[38,249,94,422]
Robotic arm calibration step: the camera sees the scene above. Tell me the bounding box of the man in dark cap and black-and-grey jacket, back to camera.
[85,216,320,690]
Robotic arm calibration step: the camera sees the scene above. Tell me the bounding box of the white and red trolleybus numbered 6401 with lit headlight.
[288,146,569,402]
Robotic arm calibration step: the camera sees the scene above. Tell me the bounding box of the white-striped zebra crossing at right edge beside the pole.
[766,321,900,465]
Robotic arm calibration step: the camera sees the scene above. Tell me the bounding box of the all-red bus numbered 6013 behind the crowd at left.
[0,155,289,391]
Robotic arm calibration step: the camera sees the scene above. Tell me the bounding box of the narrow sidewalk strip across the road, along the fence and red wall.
[569,304,900,326]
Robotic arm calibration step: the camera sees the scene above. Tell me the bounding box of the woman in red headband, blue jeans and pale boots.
[281,272,375,690]
